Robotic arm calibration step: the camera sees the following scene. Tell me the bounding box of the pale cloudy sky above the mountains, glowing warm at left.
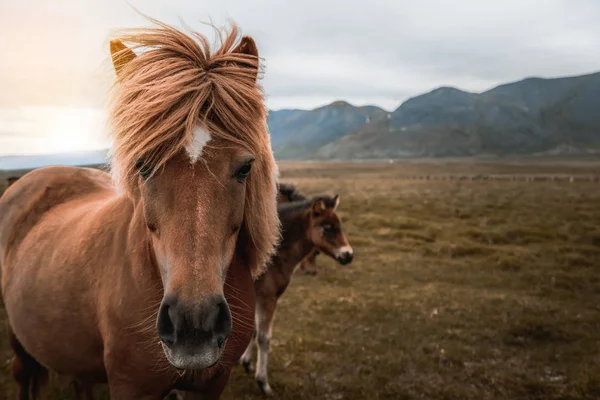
[0,0,600,155]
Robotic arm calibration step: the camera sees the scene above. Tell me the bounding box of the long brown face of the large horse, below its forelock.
[140,140,253,369]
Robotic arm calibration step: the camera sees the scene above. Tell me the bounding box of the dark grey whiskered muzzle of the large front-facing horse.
[157,295,231,369]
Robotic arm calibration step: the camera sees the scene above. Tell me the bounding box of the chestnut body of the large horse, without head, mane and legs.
[0,167,254,397]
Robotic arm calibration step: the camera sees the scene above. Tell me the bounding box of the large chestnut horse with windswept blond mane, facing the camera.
[0,20,279,400]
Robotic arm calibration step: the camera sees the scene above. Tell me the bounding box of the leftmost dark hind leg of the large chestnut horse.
[8,326,48,400]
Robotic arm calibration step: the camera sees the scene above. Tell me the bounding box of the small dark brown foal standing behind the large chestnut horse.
[240,195,353,395]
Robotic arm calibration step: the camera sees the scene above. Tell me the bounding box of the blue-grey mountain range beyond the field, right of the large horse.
[269,73,600,159]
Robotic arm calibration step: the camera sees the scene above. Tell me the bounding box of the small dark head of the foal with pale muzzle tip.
[310,195,354,265]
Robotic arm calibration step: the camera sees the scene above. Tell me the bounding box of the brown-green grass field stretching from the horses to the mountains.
[0,162,600,399]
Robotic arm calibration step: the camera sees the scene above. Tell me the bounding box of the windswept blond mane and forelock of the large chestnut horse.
[109,19,279,275]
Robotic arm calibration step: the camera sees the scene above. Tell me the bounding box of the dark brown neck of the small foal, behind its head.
[279,213,315,276]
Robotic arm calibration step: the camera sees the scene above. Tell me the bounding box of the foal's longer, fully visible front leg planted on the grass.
[256,297,277,396]
